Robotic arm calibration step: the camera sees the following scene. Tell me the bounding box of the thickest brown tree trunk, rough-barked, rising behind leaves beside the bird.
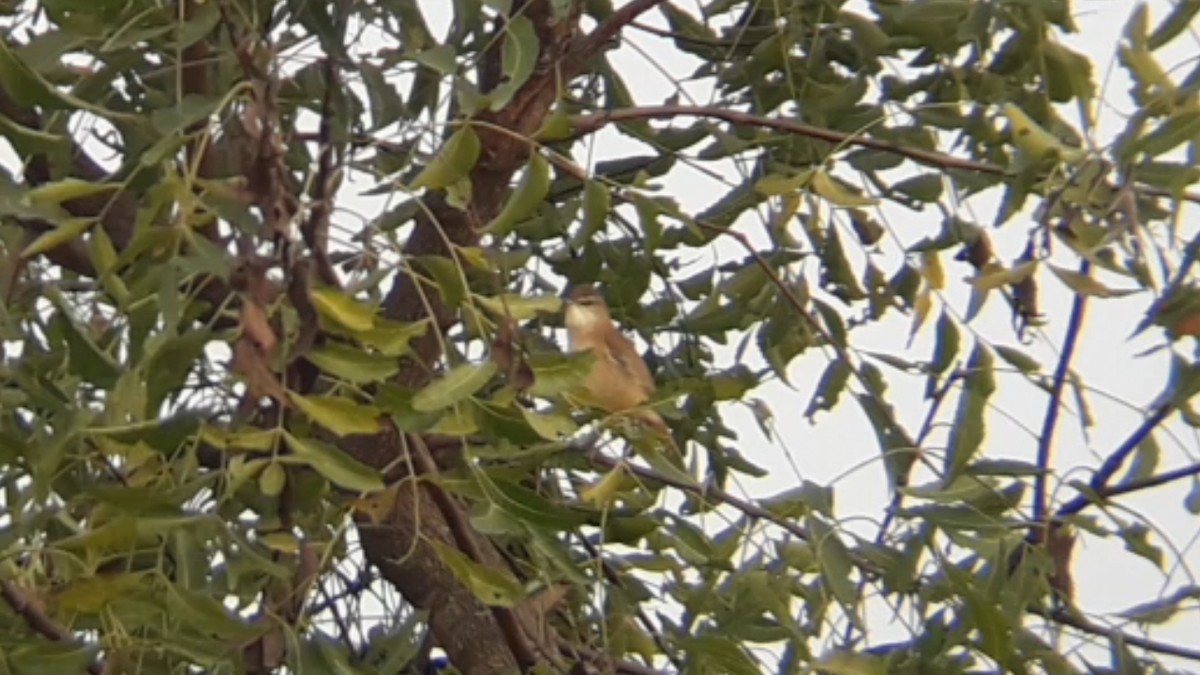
[347,0,592,675]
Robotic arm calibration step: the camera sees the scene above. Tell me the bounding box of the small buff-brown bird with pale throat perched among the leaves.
[565,286,678,452]
